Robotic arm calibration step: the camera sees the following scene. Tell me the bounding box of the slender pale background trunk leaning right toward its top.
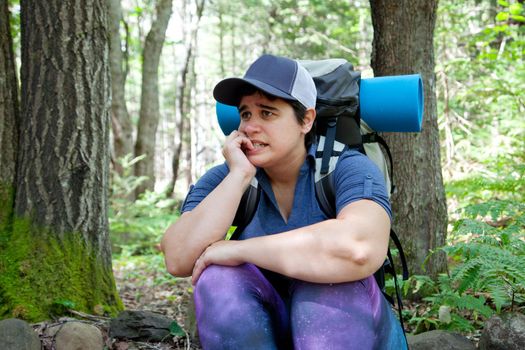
[135,0,172,195]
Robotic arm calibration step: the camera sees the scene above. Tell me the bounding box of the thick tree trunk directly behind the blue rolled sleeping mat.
[370,0,447,276]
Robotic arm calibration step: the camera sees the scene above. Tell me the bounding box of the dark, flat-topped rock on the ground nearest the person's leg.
[109,311,174,342]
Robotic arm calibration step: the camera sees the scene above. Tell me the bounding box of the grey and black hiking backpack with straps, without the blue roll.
[230,59,408,329]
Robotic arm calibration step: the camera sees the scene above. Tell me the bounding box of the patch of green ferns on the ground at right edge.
[402,200,525,333]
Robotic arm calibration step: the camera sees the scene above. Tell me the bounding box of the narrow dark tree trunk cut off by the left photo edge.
[0,0,19,234]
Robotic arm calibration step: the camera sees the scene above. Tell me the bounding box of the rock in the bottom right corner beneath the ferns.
[479,313,525,350]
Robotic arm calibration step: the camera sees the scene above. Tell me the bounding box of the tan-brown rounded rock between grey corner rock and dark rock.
[51,321,104,350]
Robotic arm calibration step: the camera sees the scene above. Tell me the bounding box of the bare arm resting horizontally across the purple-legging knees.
[193,200,390,283]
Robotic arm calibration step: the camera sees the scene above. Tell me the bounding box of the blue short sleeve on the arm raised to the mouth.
[180,163,229,213]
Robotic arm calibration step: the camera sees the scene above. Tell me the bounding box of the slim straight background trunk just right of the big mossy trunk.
[107,0,133,174]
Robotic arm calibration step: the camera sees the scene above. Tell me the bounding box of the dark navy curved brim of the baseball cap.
[213,78,297,106]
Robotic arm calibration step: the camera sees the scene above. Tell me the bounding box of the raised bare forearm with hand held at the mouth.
[161,132,256,277]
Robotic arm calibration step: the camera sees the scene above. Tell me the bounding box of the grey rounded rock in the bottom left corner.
[0,318,40,350]
